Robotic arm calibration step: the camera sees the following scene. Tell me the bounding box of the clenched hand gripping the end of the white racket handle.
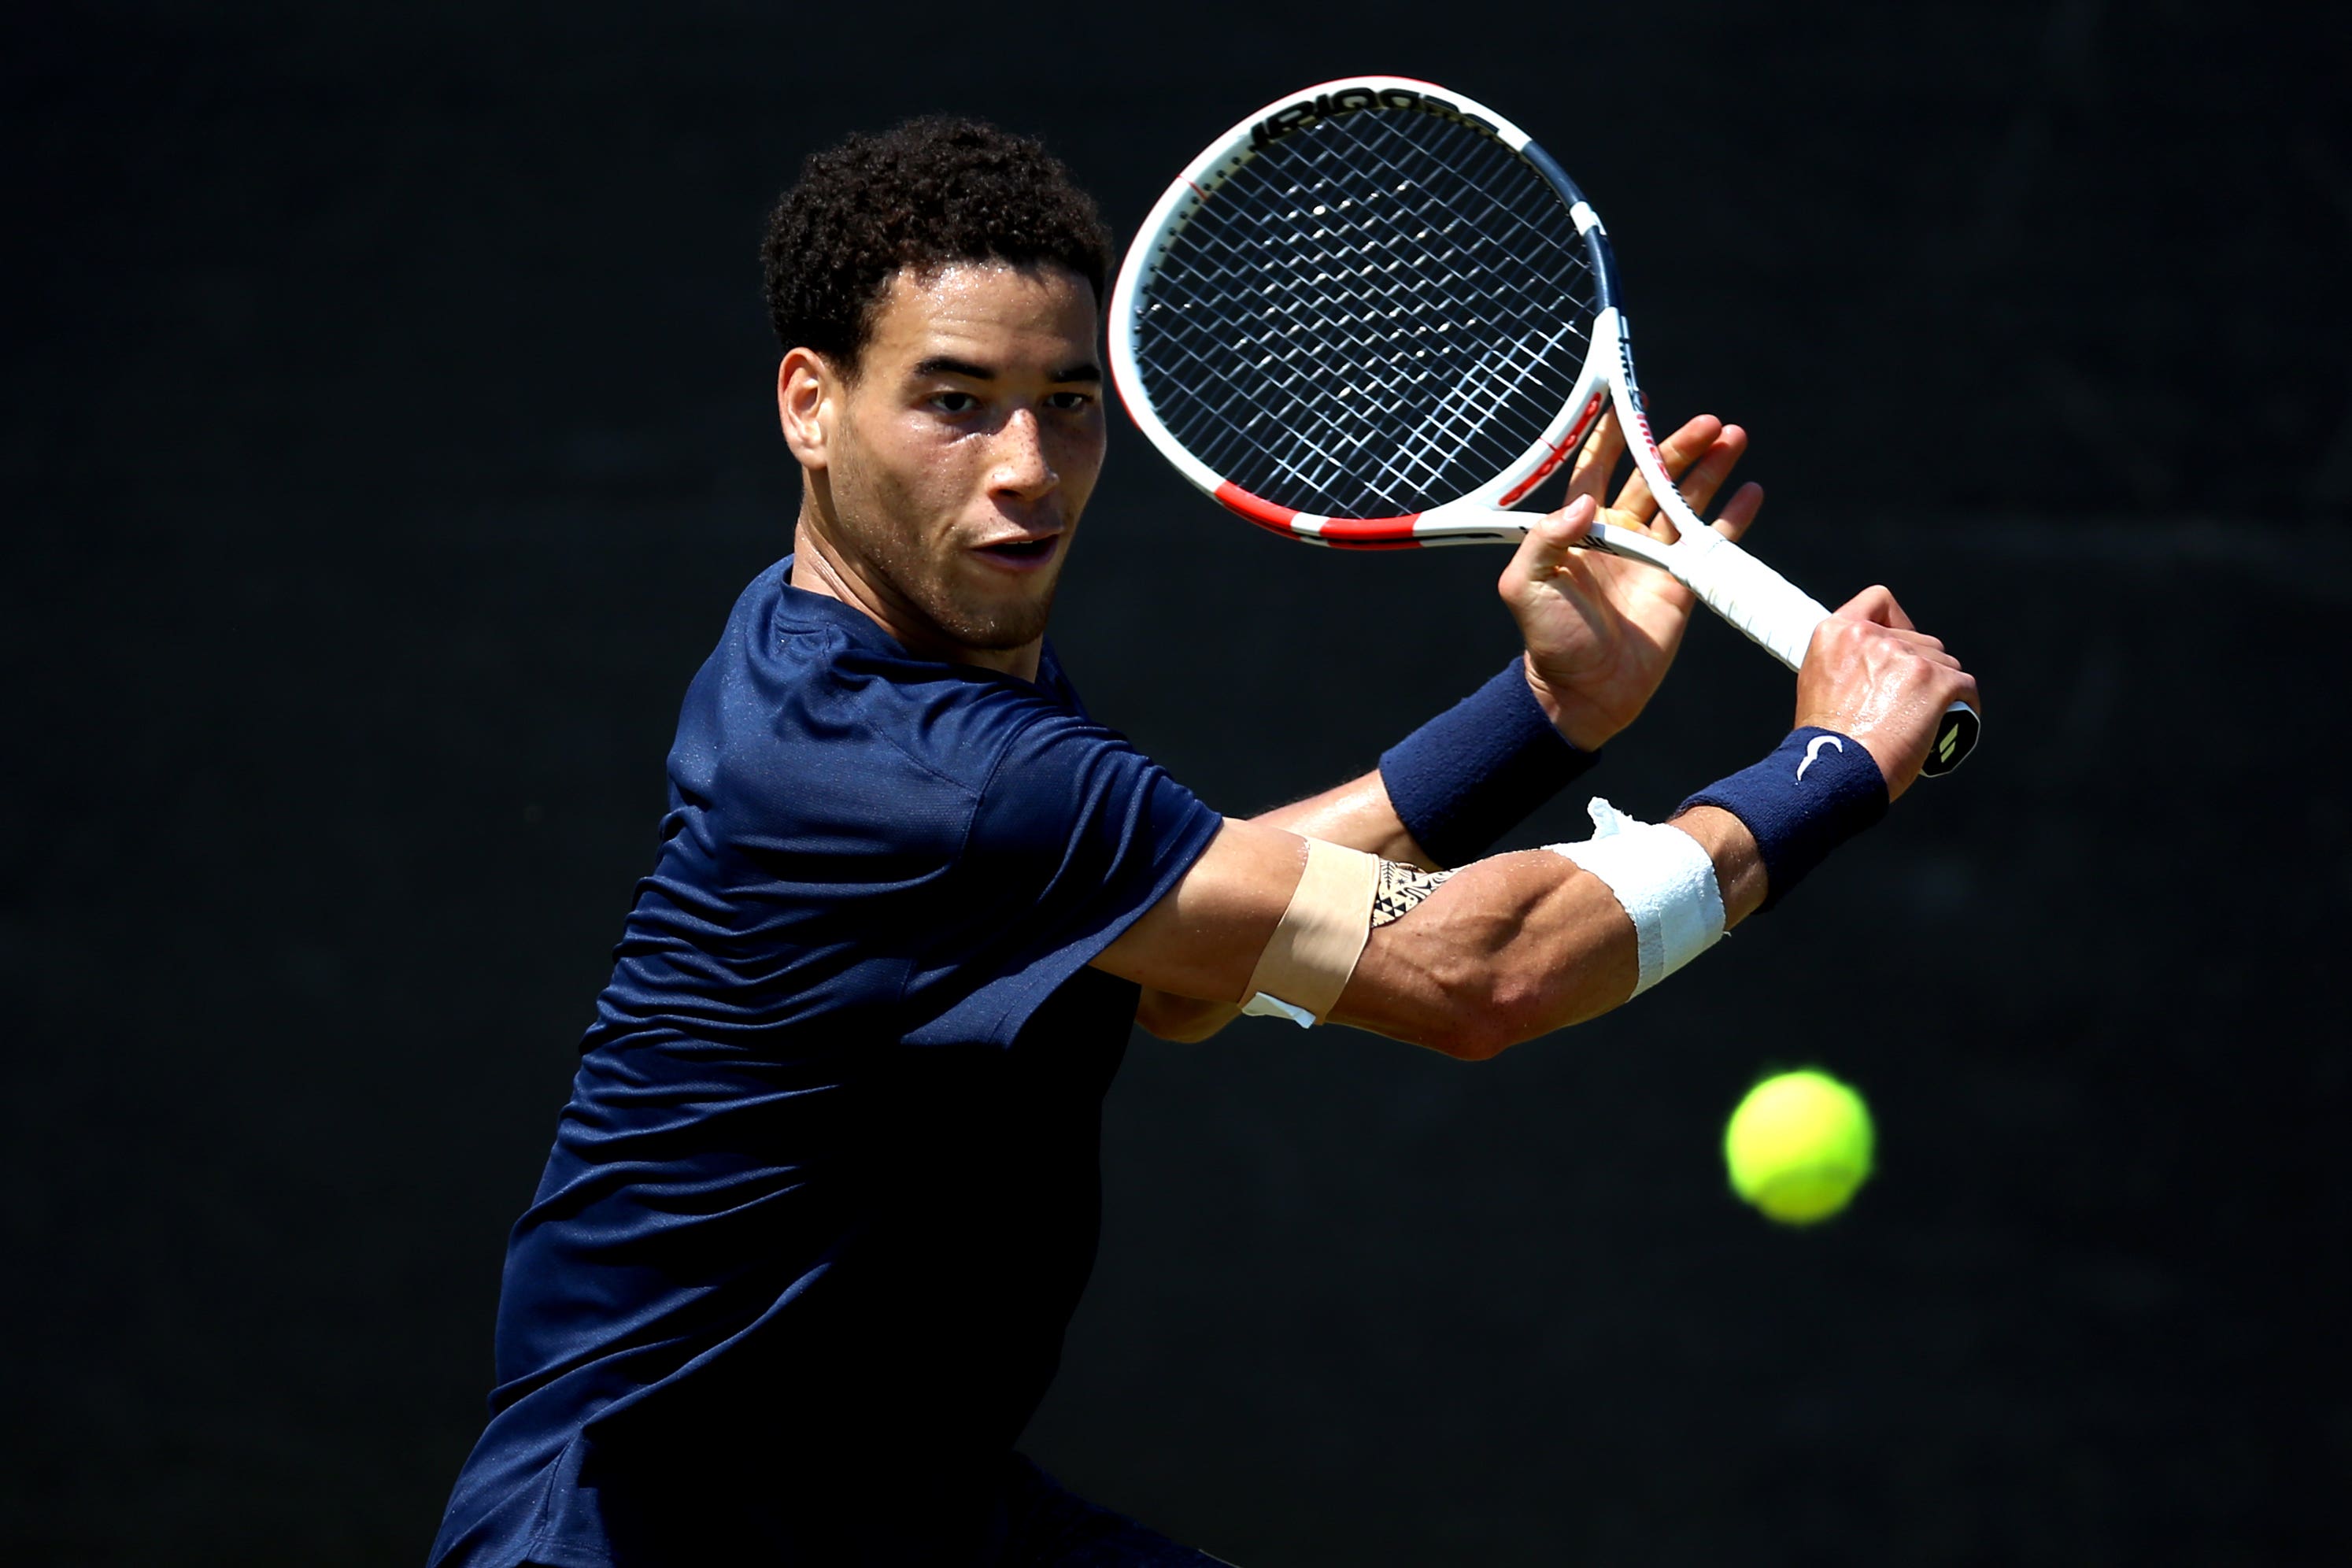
[1797,588,1983,799]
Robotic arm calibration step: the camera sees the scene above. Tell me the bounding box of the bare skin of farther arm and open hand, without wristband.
[1136,414,1764,1041]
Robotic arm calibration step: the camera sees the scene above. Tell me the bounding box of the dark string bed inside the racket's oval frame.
[1136,110,1597,517]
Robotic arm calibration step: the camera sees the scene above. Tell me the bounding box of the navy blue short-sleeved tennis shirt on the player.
[433,560,1219,1568]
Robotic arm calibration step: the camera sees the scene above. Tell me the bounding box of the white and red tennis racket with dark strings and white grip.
[1110,76,1980,776]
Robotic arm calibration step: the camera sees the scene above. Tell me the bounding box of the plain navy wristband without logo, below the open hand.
[1381,658,1599,865]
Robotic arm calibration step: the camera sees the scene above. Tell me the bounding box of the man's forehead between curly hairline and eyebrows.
[871,261,1096,360]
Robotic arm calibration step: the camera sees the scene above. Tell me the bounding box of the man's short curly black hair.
[760,115,1110,374]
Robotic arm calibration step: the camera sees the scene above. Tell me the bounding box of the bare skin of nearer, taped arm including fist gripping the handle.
[1096,588,1978,1060]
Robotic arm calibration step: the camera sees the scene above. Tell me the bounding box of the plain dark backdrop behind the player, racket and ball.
[0,0,2352,1568]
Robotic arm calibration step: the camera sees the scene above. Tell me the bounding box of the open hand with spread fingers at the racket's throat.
[1496,414,1764,753]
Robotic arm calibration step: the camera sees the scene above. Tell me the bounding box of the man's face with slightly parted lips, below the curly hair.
[788,263,1103,668]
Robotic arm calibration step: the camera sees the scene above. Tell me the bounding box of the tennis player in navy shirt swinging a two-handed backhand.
[433,120,1976,1568]
